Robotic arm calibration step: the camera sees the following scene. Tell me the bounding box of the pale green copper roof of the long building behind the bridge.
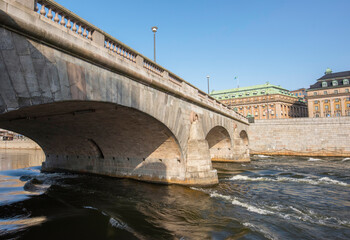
[210,83,297,100]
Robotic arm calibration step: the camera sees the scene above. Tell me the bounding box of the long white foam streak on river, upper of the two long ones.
[228,175,350,186]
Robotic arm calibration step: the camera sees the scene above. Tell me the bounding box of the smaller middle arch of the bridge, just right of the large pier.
[205,126,233,161]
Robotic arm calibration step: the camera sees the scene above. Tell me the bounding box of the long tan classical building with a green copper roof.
[210,83,307,119]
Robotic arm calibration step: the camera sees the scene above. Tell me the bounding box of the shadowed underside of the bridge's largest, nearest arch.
[0,101,186,183]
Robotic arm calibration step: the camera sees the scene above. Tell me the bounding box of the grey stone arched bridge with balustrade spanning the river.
[0,0,249,185]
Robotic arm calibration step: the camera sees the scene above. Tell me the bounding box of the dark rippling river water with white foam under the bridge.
[0,151,350,240]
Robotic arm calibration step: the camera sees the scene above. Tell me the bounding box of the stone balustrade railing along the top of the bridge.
[32,0,247,122]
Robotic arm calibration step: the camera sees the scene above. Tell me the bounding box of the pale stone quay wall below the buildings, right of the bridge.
[248,117,350,157]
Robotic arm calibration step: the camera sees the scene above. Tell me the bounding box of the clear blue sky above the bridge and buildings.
[56,0,350,91]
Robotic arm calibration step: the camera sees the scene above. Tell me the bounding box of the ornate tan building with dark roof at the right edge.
[307,68,350,117]
